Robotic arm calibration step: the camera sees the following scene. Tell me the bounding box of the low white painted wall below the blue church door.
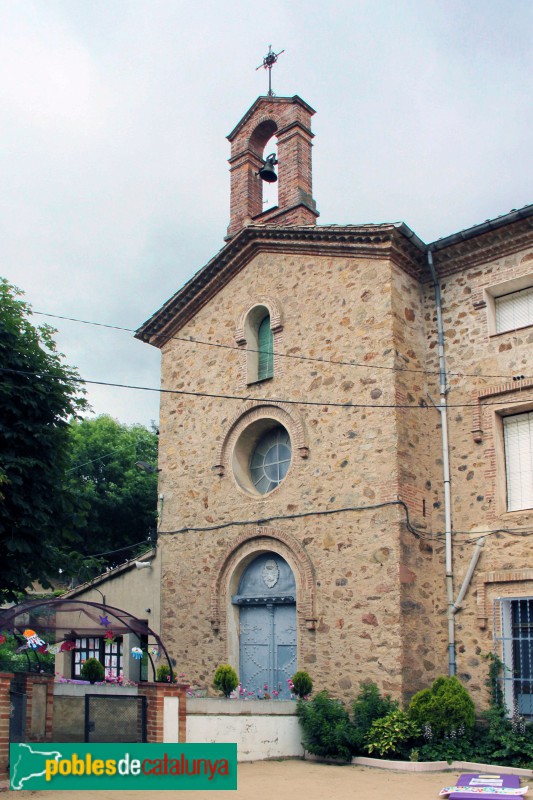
[187,698,304,761]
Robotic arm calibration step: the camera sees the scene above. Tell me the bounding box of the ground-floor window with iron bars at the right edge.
[494,597,533,717]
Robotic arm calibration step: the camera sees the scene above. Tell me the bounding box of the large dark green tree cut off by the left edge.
[0,278,86,599]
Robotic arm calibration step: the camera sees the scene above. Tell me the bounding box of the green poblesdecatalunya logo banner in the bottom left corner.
[9,743,237,791]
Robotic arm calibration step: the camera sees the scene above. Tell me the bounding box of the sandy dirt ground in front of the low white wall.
[4,760,486,800]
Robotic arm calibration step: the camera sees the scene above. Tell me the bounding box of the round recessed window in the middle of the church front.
[233,418,291,495]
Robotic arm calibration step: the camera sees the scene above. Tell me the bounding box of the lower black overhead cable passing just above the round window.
[4,367,523,411]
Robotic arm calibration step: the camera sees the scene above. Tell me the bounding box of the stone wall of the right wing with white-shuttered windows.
[427,242,533,704]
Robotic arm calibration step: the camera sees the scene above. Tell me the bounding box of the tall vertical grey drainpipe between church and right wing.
[427,250,456,675]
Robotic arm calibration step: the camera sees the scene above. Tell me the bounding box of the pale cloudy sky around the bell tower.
[0,0,533,425]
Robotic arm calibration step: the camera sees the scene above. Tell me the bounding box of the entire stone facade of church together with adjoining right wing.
[137,98,533,703]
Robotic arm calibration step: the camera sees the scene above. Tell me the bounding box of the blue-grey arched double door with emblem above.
[231,552,297,698]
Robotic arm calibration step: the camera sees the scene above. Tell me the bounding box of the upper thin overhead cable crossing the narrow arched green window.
[33,311,531,380]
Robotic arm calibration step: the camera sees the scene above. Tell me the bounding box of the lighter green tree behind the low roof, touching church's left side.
[63,415,157,579]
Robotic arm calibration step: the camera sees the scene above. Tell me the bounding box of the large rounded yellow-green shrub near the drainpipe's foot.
[408,675,476,739]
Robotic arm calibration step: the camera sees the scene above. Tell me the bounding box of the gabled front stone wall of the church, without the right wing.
[159,247,437,697]
